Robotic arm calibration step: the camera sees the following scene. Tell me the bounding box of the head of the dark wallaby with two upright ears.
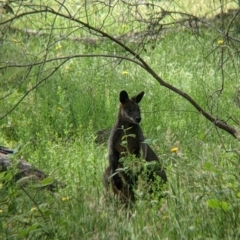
[119,90,144,124]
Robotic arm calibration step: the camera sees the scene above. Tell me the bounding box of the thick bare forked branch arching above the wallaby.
[0,5,238,138]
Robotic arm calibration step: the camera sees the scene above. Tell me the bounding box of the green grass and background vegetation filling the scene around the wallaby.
[0,0,240,239]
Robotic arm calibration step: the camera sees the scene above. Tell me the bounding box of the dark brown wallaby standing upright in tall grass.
[104,91,167,201]
